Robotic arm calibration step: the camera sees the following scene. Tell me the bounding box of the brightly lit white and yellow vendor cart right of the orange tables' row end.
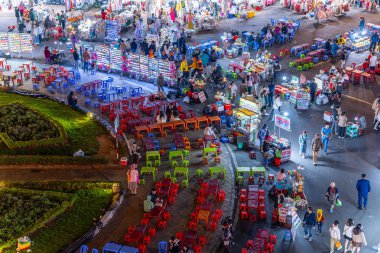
[233,96,261,142]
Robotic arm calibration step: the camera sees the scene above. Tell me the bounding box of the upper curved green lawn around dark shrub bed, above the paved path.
[0,91,107,156]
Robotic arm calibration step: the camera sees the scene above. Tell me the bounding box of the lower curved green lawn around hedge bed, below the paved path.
[0,182,114,253]
